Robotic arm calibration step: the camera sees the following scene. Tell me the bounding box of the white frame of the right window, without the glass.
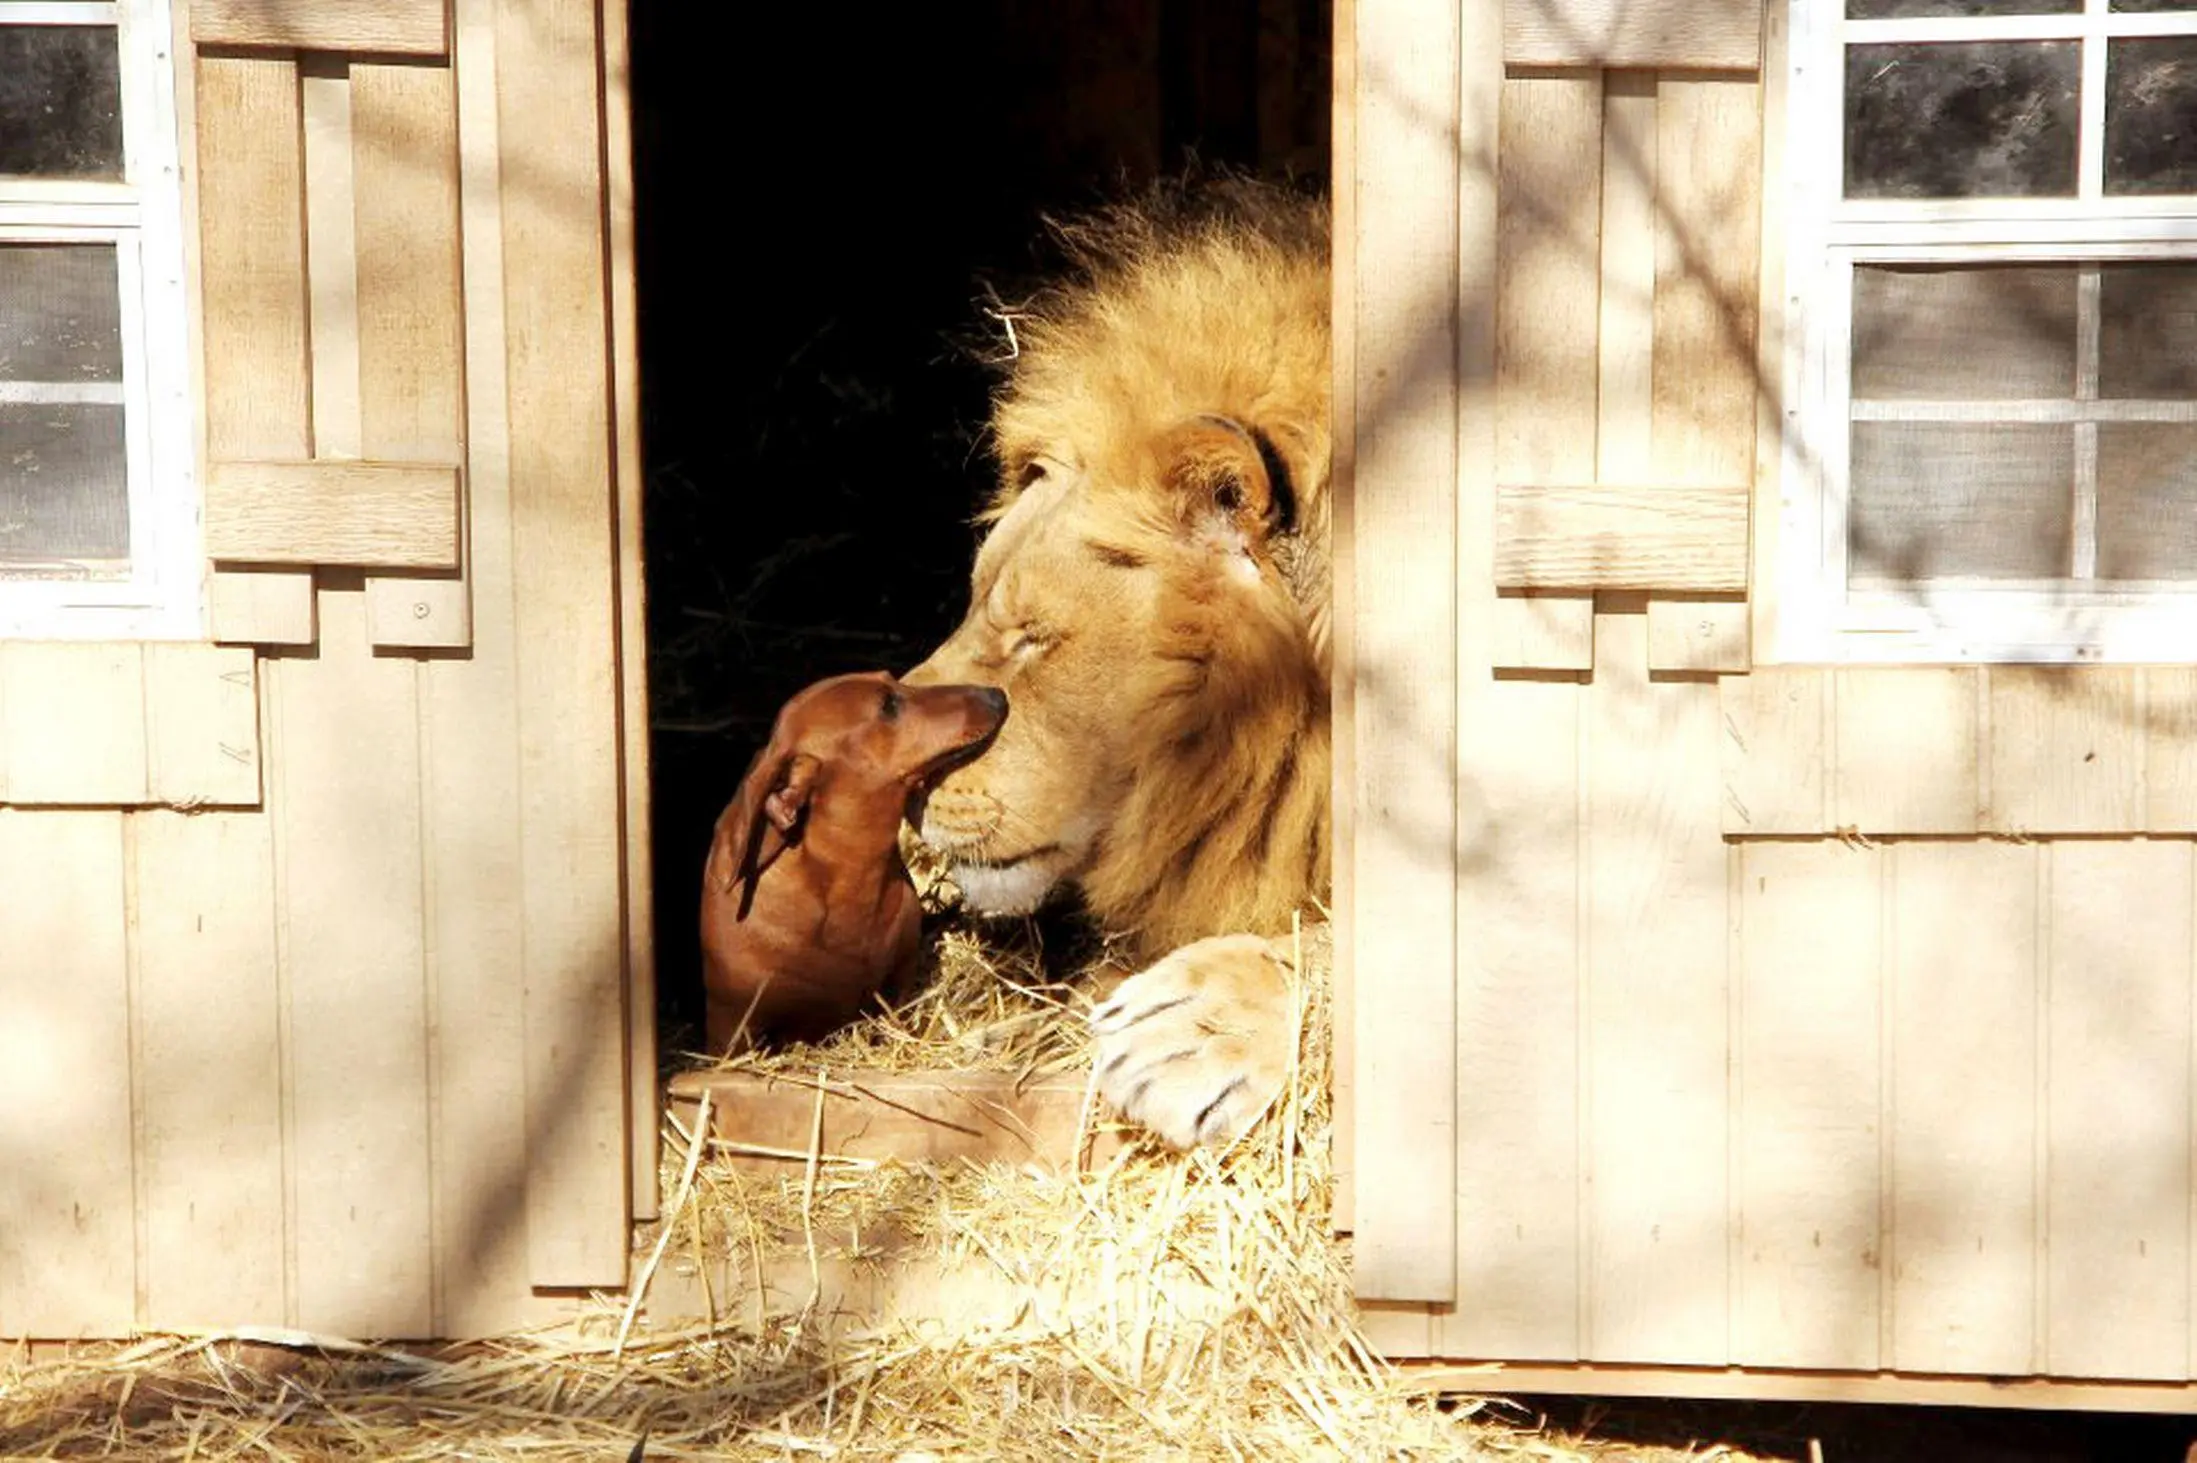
[1766,0,2197,663]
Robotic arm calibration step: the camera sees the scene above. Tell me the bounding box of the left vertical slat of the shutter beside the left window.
[193,55,314,644]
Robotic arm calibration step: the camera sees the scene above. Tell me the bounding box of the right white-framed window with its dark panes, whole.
[1773,0,2197,661]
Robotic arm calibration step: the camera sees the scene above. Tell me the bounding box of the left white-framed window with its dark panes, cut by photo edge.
[0,0,202,639]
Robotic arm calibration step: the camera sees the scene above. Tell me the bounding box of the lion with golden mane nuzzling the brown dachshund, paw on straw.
[910,182,1331,1149]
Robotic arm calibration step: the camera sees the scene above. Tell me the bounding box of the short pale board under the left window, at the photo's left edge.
[0,639,145,799]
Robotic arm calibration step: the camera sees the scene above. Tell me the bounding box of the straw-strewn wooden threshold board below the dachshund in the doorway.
[666,1070,1127,1169]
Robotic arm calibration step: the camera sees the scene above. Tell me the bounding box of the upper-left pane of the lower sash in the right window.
[1854,264,2076,402]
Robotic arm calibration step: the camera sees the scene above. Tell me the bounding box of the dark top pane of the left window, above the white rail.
[0,24,123,178]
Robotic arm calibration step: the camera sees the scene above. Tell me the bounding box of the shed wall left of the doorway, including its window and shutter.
[0,0,655,1338]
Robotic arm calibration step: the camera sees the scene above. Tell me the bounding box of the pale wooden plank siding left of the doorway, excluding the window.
[0,0,655,1338]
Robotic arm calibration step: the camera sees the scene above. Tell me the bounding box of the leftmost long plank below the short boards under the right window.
[1731,841,1883,1371]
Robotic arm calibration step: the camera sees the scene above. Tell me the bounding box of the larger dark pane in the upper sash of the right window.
[1845,42,2081,198]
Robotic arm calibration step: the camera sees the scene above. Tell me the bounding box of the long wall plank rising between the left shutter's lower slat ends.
[266,580,433,1336]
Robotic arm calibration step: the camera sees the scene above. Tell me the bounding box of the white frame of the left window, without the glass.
[0,0,204,639]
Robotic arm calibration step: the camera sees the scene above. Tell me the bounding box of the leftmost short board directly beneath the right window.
[1718,670,1832,835]
